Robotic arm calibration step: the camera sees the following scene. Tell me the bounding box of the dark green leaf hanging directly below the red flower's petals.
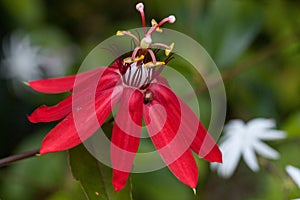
[69,144,132,200]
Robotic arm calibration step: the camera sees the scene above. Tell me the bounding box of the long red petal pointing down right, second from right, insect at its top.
[144,84,198,188]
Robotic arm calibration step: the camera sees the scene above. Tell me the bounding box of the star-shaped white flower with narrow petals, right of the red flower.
[211,118,286,178]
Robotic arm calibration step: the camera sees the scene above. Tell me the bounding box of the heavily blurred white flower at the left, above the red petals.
[1,33,74,82]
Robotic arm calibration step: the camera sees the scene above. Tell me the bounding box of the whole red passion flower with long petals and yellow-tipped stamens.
[28,3,222,191]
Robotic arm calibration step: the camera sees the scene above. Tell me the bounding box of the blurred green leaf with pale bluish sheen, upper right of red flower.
[197,0,262,68]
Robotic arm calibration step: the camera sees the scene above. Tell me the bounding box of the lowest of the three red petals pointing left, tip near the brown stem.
[40,86,121,154]
